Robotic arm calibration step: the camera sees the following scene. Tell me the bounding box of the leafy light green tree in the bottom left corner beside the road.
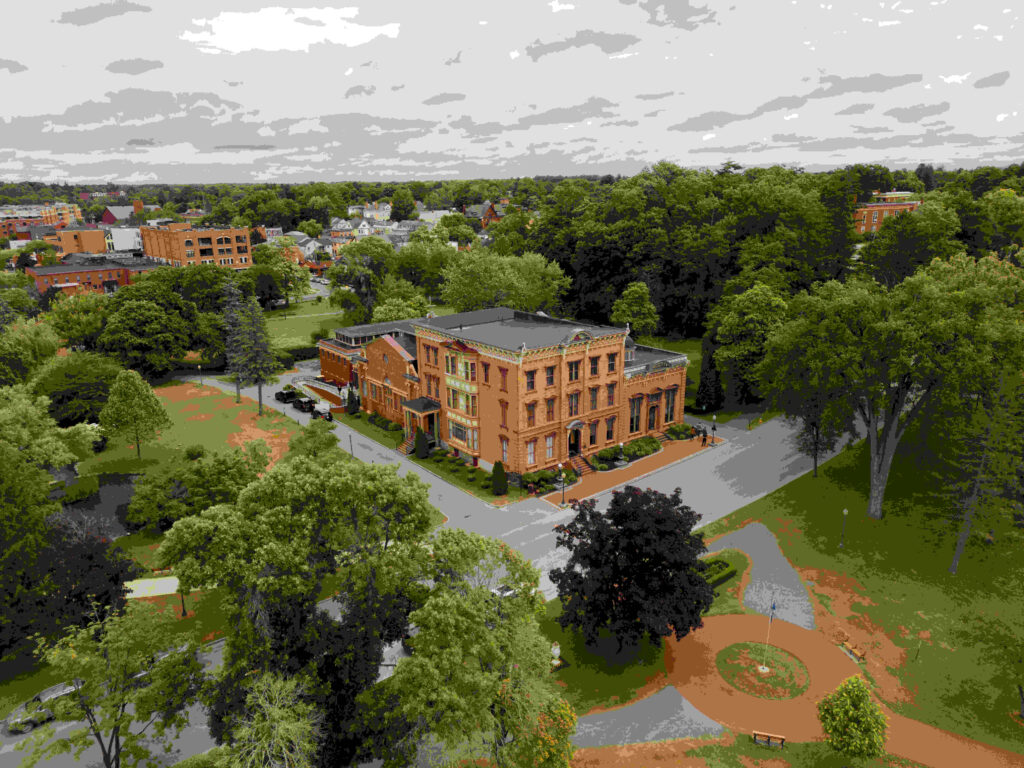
[18,602,203,768]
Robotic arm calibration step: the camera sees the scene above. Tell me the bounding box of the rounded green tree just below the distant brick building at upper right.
[859,201,959,287]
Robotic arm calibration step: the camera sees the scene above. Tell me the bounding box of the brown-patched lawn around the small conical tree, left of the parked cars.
[78,383,299,475]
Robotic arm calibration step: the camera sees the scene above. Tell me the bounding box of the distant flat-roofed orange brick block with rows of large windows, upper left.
[139,222,252,269]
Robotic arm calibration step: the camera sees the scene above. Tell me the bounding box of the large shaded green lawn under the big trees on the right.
[688,433,1024,752]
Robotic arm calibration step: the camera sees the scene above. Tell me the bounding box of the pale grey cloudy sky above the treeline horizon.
[0,0,1024,182]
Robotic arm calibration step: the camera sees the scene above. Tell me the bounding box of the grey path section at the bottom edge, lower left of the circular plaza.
[572,685,722,746]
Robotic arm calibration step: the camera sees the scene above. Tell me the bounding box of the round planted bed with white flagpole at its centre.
[715,643,811,698]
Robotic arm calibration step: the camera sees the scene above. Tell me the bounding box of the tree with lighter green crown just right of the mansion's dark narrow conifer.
[708,283,786,404]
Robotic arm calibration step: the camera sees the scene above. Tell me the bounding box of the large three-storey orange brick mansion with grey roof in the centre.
[318,307,687,474]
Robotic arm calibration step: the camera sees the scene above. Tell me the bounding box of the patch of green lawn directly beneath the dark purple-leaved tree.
[541,599,668,716]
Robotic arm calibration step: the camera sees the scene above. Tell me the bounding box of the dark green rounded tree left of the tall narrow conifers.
[98,301,193,378]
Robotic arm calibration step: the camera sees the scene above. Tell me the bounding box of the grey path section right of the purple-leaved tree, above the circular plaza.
[708,522,814,630]
